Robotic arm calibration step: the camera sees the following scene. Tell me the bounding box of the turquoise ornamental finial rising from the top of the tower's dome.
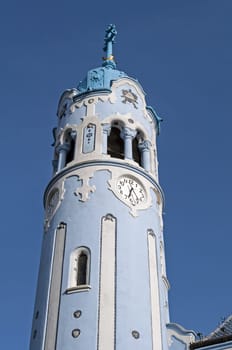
[102,24,117,68]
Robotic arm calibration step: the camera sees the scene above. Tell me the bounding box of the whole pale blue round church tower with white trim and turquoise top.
[30,25,172,350]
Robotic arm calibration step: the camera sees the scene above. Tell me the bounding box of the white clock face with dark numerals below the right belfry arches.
[116,176,146,206]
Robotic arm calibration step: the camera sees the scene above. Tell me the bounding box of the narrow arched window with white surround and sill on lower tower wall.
[67,247,91,293]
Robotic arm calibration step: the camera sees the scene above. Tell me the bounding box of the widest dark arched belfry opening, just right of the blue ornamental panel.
[107,126,124,159]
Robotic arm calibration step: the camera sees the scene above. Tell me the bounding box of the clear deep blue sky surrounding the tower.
[0,0,232,350]
